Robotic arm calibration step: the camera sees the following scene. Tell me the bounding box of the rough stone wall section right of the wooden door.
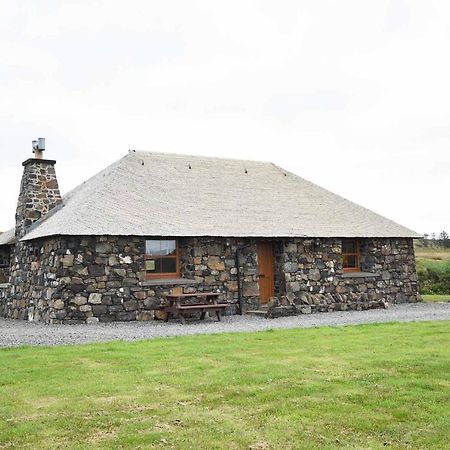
[269,238,420,317]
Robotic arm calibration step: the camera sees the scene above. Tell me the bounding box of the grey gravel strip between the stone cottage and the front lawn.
[0,303,450,347]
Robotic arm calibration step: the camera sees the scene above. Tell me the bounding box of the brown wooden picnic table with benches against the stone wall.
[162,292,228,323]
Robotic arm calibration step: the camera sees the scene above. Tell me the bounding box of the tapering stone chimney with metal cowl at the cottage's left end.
[16,138,61,241]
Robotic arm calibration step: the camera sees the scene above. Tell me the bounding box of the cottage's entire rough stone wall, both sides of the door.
[0,236,419,323]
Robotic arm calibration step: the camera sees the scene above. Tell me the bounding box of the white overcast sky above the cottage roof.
[0,0,450,233]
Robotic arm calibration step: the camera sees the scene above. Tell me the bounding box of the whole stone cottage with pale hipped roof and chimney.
[0,141,419,323]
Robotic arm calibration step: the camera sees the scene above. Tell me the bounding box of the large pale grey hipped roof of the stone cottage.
[16,151,418,240]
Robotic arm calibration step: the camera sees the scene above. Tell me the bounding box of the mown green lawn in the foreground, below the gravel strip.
[0,322,450,449]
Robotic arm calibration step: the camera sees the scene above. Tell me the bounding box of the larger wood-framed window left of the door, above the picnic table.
[145,239,180,278]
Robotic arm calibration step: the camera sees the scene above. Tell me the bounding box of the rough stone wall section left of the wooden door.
[4,236,259,323]
